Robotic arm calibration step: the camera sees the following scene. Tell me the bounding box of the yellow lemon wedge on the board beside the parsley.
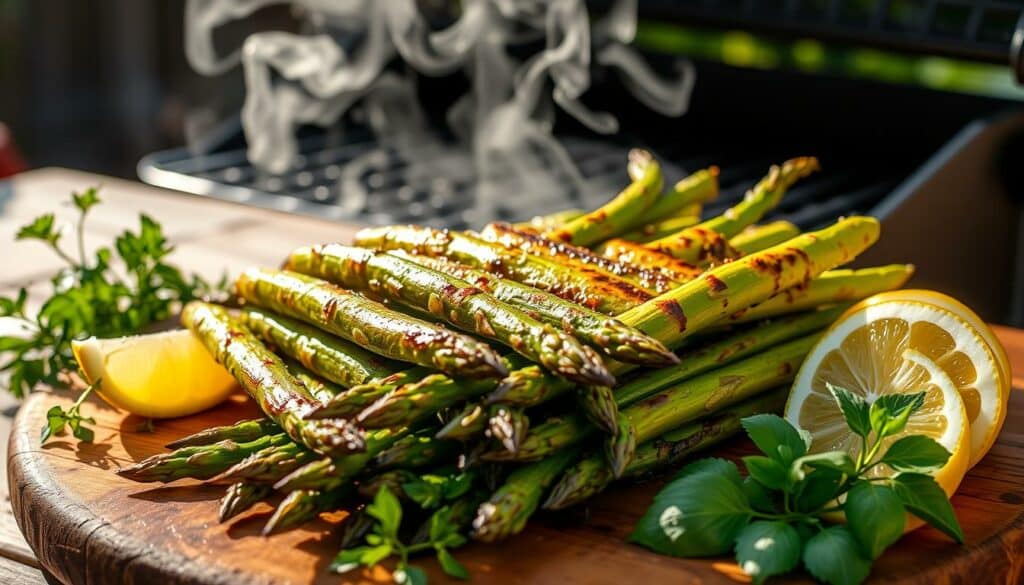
[72,330,236,418]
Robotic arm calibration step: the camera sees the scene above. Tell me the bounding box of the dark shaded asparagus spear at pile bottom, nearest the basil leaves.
[543,388,788,510]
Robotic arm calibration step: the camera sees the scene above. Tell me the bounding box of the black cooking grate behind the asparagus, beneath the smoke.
[139,120,921,228]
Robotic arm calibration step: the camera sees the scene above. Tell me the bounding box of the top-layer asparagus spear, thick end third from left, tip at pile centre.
[286,244,614,384]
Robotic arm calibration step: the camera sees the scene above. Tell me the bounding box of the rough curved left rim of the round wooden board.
[7,392,276,585]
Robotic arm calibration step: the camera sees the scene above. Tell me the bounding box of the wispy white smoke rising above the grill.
[185,0,695,216]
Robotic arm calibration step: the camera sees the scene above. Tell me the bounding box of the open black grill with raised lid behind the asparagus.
[138,0,1024,325]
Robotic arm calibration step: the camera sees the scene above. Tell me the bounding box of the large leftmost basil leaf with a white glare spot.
[630,471,752,556]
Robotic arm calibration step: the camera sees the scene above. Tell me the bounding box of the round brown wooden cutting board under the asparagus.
[7,328,1024,585]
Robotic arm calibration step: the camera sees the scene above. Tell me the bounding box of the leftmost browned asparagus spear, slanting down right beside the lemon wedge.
[181,301,364,461]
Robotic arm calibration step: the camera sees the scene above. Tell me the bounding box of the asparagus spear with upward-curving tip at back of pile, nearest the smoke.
[547,149,664,246]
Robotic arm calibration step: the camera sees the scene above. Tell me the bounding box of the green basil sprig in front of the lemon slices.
[630,384,964,585]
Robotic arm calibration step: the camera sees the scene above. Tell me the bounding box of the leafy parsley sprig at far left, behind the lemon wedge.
[0,187,225,441]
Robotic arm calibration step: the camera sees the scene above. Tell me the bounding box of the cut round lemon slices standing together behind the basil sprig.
[785,301,978,499]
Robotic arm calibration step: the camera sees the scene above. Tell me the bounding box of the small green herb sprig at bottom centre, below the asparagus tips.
[331,487,469,585]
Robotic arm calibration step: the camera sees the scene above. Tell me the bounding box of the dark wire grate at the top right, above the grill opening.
[641,0,1024,64]
